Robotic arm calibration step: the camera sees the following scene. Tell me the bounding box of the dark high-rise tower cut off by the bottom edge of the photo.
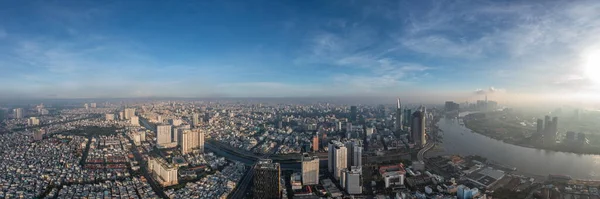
[253,159,281,199]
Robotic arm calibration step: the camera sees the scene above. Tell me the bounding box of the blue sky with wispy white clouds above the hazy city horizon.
[0,0,600,100]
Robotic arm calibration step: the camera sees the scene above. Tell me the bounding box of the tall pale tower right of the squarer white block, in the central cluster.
[327,140,348,180]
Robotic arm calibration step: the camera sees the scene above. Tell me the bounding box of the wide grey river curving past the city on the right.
[436,114,600,180]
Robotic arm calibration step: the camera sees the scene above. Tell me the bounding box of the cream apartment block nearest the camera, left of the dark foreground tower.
[148,156,178,187]
